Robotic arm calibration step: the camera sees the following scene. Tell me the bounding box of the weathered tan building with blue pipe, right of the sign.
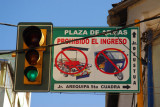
[106,0,160,107]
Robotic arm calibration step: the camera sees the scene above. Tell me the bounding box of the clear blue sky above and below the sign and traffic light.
[0,0,121,107]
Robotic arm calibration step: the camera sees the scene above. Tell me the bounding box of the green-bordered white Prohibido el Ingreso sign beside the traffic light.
[50,27,140,92]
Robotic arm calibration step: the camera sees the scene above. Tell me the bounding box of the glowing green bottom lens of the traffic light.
[24,66,38,82]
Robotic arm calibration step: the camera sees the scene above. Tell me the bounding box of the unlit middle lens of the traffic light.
[25,49,39,65]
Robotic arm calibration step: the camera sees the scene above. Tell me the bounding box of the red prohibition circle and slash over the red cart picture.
[55,48,88,75]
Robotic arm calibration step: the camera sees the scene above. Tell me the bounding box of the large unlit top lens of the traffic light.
[23,26,42,47]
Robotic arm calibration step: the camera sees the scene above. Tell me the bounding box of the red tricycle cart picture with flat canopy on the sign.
[55,46,92,79]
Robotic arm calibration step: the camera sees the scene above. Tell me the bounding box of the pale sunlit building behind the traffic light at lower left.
[0,55,31,107]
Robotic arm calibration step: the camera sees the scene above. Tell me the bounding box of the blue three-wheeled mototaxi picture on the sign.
[95,49,128,80]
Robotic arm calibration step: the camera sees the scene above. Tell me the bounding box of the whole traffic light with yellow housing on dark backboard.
[14,22,53,91]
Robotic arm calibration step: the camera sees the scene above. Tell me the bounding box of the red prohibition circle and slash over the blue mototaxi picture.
[95,48,128,74]
